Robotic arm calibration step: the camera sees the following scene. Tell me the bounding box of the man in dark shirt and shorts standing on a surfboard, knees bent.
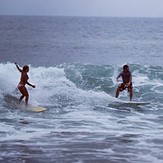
[116,65,133,101]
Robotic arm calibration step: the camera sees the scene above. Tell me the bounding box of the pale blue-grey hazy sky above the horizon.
[0,0,163,17]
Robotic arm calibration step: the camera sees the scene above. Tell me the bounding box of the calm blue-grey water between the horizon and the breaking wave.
[0,16,163,66]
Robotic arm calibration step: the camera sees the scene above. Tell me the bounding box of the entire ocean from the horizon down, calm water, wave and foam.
[0,16,163,163]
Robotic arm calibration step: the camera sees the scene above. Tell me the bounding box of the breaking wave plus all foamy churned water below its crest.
[0,63,163,163]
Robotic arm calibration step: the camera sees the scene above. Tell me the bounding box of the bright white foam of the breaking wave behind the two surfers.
[0,63,162,105]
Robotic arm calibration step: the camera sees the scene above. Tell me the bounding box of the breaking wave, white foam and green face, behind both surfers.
[0,63,163,105]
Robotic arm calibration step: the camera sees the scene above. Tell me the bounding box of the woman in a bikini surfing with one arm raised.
[15,63,35,107]
